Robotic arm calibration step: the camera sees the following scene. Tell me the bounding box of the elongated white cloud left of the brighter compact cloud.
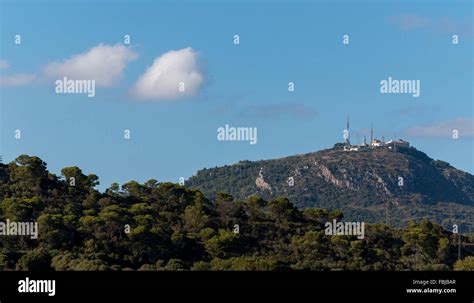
[44,44,138,87]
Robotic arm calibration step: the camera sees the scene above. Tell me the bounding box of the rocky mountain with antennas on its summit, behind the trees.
[186,144,474,232]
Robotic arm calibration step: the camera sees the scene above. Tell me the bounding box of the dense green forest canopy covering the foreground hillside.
[0,155,474,271]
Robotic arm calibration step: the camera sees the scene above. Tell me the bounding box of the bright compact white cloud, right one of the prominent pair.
[130,47,204,100]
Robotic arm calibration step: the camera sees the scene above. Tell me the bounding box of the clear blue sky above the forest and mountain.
[0,0,474,189]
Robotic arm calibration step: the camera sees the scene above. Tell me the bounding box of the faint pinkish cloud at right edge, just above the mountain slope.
[406,118,474,138]
